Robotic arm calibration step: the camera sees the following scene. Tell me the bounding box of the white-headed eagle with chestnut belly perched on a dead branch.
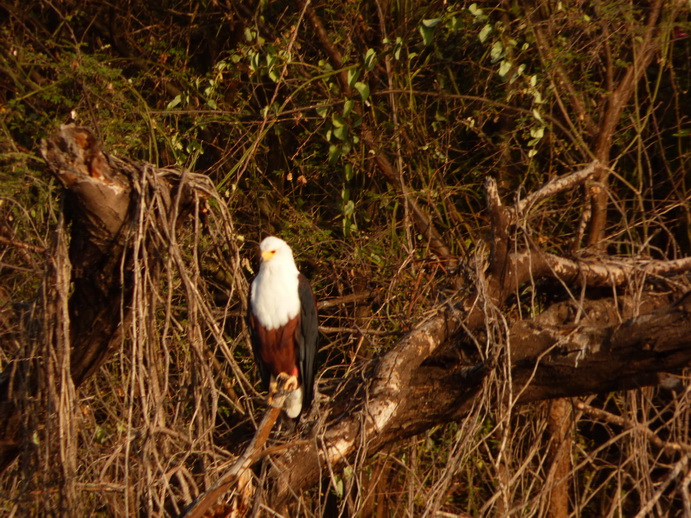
[248,236,318,419]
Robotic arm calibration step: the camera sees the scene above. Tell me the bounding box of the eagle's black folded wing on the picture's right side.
[296,274,319,411]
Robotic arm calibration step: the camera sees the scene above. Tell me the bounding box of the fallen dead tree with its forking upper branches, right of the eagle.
[250,169,691,505]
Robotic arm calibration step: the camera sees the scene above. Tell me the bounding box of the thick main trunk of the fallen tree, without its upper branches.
[262,292,691,507]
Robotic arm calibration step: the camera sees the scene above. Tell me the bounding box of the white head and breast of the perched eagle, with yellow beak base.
[250,236,300,329]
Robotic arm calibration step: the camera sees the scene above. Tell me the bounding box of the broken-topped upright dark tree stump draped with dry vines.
[0,125,189,472]
